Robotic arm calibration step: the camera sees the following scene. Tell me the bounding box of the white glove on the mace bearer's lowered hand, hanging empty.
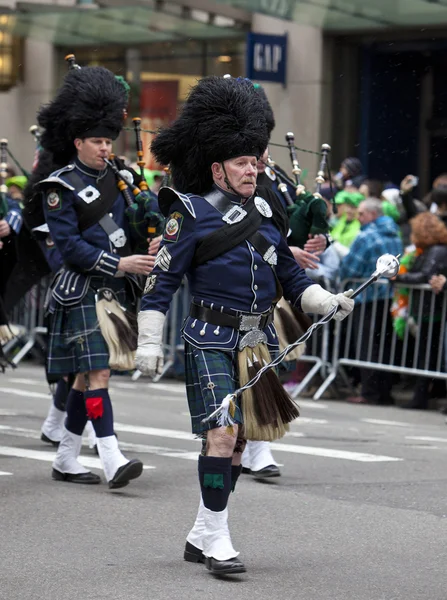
[135,310,166,377]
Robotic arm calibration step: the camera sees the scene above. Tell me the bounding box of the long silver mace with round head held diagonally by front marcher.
[201,254,400,423]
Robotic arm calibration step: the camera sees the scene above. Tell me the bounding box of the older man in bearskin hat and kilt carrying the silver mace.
[136,77,354,574]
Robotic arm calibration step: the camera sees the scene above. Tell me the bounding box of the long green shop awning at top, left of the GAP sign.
[0,0,246,47]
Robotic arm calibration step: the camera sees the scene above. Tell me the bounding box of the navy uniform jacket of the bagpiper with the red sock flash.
[39,159,136,305]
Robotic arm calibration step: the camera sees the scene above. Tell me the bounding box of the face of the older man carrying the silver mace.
[211,156,258,198]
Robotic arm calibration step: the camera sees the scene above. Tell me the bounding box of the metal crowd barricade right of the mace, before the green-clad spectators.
[313,279,447,400]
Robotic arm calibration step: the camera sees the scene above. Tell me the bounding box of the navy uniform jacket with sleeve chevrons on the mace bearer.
[141,185,314,350]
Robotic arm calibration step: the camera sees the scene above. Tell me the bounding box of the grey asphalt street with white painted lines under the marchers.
[0,363,447,600]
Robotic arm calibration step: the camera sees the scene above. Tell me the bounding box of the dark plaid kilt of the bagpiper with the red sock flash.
[47,277,128,375]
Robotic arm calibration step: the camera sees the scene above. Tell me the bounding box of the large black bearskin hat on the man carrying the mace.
[151,76,269,194]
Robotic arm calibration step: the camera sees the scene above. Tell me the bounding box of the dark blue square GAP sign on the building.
[247,32,287,86]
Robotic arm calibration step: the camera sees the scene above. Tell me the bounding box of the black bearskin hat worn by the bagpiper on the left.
[37,67,128,165]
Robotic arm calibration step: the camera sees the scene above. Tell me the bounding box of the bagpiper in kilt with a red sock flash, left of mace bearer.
[34,67,153,489]
